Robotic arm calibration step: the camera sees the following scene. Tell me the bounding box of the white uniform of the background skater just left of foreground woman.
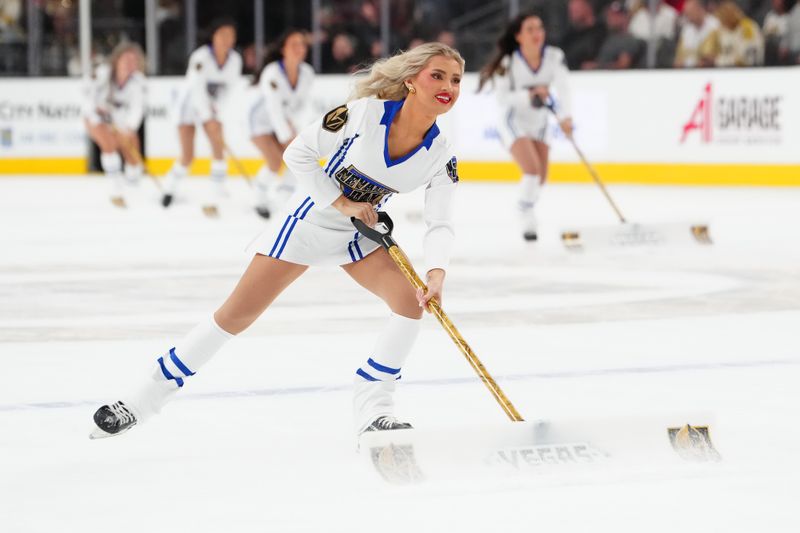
[247,61,314,144]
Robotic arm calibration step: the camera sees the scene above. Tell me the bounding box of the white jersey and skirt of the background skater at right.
[495,46,572,148]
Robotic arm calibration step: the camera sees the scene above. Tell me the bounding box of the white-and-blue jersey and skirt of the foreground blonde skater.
[250,98,458,272]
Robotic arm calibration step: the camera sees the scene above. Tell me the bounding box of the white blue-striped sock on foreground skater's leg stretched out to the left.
[126,316,234,420]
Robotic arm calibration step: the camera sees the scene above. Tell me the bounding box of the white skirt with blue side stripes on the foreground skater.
[247,194,380,266]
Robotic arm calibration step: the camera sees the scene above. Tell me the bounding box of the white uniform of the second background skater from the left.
[177,45,242,125]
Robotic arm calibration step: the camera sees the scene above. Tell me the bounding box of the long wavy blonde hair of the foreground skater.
[350,43,464,100]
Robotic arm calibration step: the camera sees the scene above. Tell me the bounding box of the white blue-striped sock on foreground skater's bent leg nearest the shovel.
[353,314,421,433]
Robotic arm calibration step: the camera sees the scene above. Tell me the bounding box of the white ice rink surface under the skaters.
[0,178,800,533]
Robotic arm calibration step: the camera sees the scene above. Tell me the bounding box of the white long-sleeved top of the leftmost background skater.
[83,64,147,131]
